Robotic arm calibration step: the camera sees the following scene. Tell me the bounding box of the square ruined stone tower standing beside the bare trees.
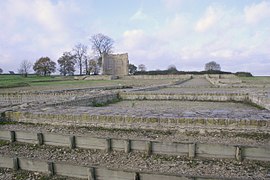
[101,53,129,77]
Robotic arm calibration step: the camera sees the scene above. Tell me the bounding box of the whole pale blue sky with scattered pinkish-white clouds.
[0,0,270,75]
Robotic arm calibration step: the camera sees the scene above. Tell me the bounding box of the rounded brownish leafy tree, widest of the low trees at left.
[33,57,56,76]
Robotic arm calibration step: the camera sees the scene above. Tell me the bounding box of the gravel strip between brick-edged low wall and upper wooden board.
[0,123,270,146]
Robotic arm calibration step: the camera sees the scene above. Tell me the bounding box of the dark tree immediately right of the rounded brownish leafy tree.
[57,52,76,76]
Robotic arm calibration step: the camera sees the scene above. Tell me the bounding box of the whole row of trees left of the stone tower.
[0,33,114,77]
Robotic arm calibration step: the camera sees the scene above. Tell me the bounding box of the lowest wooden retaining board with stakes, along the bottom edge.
[0,156,213,180]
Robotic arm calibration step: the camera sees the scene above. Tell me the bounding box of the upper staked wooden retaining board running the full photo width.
[0,130,270,161]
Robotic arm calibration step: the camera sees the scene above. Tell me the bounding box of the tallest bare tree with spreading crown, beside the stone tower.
[90,33,114,66]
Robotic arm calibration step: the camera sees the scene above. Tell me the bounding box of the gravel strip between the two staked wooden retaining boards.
[0,143,270,179]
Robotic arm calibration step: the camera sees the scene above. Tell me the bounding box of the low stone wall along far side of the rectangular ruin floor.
[119,92,248,102]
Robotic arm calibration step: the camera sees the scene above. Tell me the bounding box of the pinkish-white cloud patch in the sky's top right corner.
[244,1,270,24]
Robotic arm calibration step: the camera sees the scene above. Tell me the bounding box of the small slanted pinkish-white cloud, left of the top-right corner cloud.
[195,6,221,32]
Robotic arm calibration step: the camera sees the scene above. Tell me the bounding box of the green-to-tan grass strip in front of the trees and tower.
[0,74,172,92]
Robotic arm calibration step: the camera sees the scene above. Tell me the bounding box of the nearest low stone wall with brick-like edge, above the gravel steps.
[2,111,270,132]
